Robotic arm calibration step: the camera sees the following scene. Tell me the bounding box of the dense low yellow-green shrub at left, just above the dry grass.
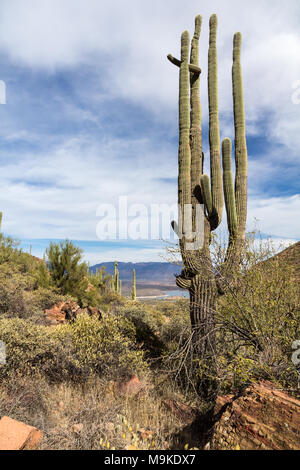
[0,315,147,380]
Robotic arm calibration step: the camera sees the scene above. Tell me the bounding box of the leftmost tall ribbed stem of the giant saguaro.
[178,31,191,234]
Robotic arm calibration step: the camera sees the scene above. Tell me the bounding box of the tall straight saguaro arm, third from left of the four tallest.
[208,15,223,230]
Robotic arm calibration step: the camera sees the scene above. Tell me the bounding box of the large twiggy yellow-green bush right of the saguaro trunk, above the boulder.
[216,236,300,389]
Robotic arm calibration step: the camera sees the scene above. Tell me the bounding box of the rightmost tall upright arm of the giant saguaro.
[232,33,247,238]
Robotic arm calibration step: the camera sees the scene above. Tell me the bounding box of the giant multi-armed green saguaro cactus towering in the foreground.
[168,15,247,370]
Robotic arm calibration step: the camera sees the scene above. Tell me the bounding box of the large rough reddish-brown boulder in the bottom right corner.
[208,382,300,450]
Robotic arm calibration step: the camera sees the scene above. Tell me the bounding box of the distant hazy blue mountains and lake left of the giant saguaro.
[90,262,181,295]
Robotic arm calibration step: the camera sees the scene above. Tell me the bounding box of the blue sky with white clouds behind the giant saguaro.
[0,0,300,262]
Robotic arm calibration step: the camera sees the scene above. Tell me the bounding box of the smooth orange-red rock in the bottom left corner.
[0,416,43,450]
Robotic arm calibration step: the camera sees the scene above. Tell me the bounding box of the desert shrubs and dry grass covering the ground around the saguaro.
[0,218,300,449]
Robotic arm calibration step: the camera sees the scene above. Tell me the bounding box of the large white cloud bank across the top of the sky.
[0,0,300,159]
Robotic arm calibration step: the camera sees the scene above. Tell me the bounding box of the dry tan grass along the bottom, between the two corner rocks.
[0,375,200,450]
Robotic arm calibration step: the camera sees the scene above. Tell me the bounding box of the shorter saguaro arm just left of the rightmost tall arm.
[222,139,237,237]
